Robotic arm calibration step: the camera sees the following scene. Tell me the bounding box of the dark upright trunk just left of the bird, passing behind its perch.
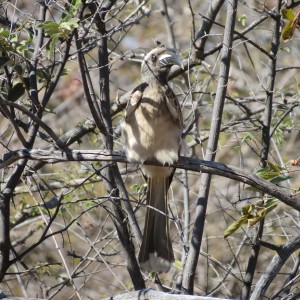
[85,0,145,290]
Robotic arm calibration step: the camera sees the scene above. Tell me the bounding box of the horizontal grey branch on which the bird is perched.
[0,149,300,211]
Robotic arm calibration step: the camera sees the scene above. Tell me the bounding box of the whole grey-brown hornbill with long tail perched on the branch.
[122,46,183,272]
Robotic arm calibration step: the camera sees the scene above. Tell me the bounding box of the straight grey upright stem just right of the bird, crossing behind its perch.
[182,0,237,294]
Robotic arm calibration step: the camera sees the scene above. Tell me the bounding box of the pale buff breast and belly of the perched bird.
[123,91,182,164]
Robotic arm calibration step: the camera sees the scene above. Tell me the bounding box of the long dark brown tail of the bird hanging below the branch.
[139,176,174,272]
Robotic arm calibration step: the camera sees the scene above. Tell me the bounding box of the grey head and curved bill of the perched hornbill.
[141,45,183,82]
